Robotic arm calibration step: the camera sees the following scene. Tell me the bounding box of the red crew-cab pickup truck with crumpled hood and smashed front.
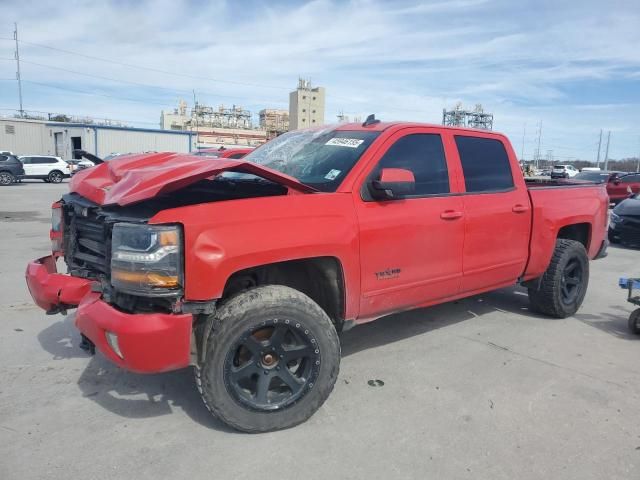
[26,118,608,432]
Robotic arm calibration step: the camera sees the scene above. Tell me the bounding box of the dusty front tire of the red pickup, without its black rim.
[195,285,340,433]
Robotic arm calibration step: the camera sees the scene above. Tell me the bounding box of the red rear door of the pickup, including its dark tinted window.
[454,133,532,293]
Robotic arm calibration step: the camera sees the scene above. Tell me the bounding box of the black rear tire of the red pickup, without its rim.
[529,239,589,318]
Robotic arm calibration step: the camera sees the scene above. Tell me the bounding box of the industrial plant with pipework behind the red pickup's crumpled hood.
[160,100,267,148]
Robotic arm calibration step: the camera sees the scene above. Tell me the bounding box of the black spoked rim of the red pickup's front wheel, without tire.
[224,319,321,411]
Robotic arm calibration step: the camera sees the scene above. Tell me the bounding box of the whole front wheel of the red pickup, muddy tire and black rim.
[196,285,340,433]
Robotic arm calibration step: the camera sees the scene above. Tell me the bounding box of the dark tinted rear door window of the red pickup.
[455,135,513,192]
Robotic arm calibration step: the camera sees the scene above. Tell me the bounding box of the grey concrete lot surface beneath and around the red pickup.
[0,182,640,480]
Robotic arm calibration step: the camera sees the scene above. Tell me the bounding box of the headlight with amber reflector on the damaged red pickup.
[111,223,183,296]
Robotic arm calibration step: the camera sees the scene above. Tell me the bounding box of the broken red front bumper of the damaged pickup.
[26,256,193,373]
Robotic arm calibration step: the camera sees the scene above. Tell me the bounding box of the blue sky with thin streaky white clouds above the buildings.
[0,0,640,161]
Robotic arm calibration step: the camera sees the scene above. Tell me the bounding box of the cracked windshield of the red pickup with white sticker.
[243,126,380,192]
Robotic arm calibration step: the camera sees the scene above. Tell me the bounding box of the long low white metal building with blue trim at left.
[0,117,195,160]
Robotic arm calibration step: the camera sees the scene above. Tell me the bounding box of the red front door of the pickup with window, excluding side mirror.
[355,128,464,319]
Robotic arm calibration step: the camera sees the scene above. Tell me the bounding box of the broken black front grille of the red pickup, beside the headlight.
[64,204,111,278]
